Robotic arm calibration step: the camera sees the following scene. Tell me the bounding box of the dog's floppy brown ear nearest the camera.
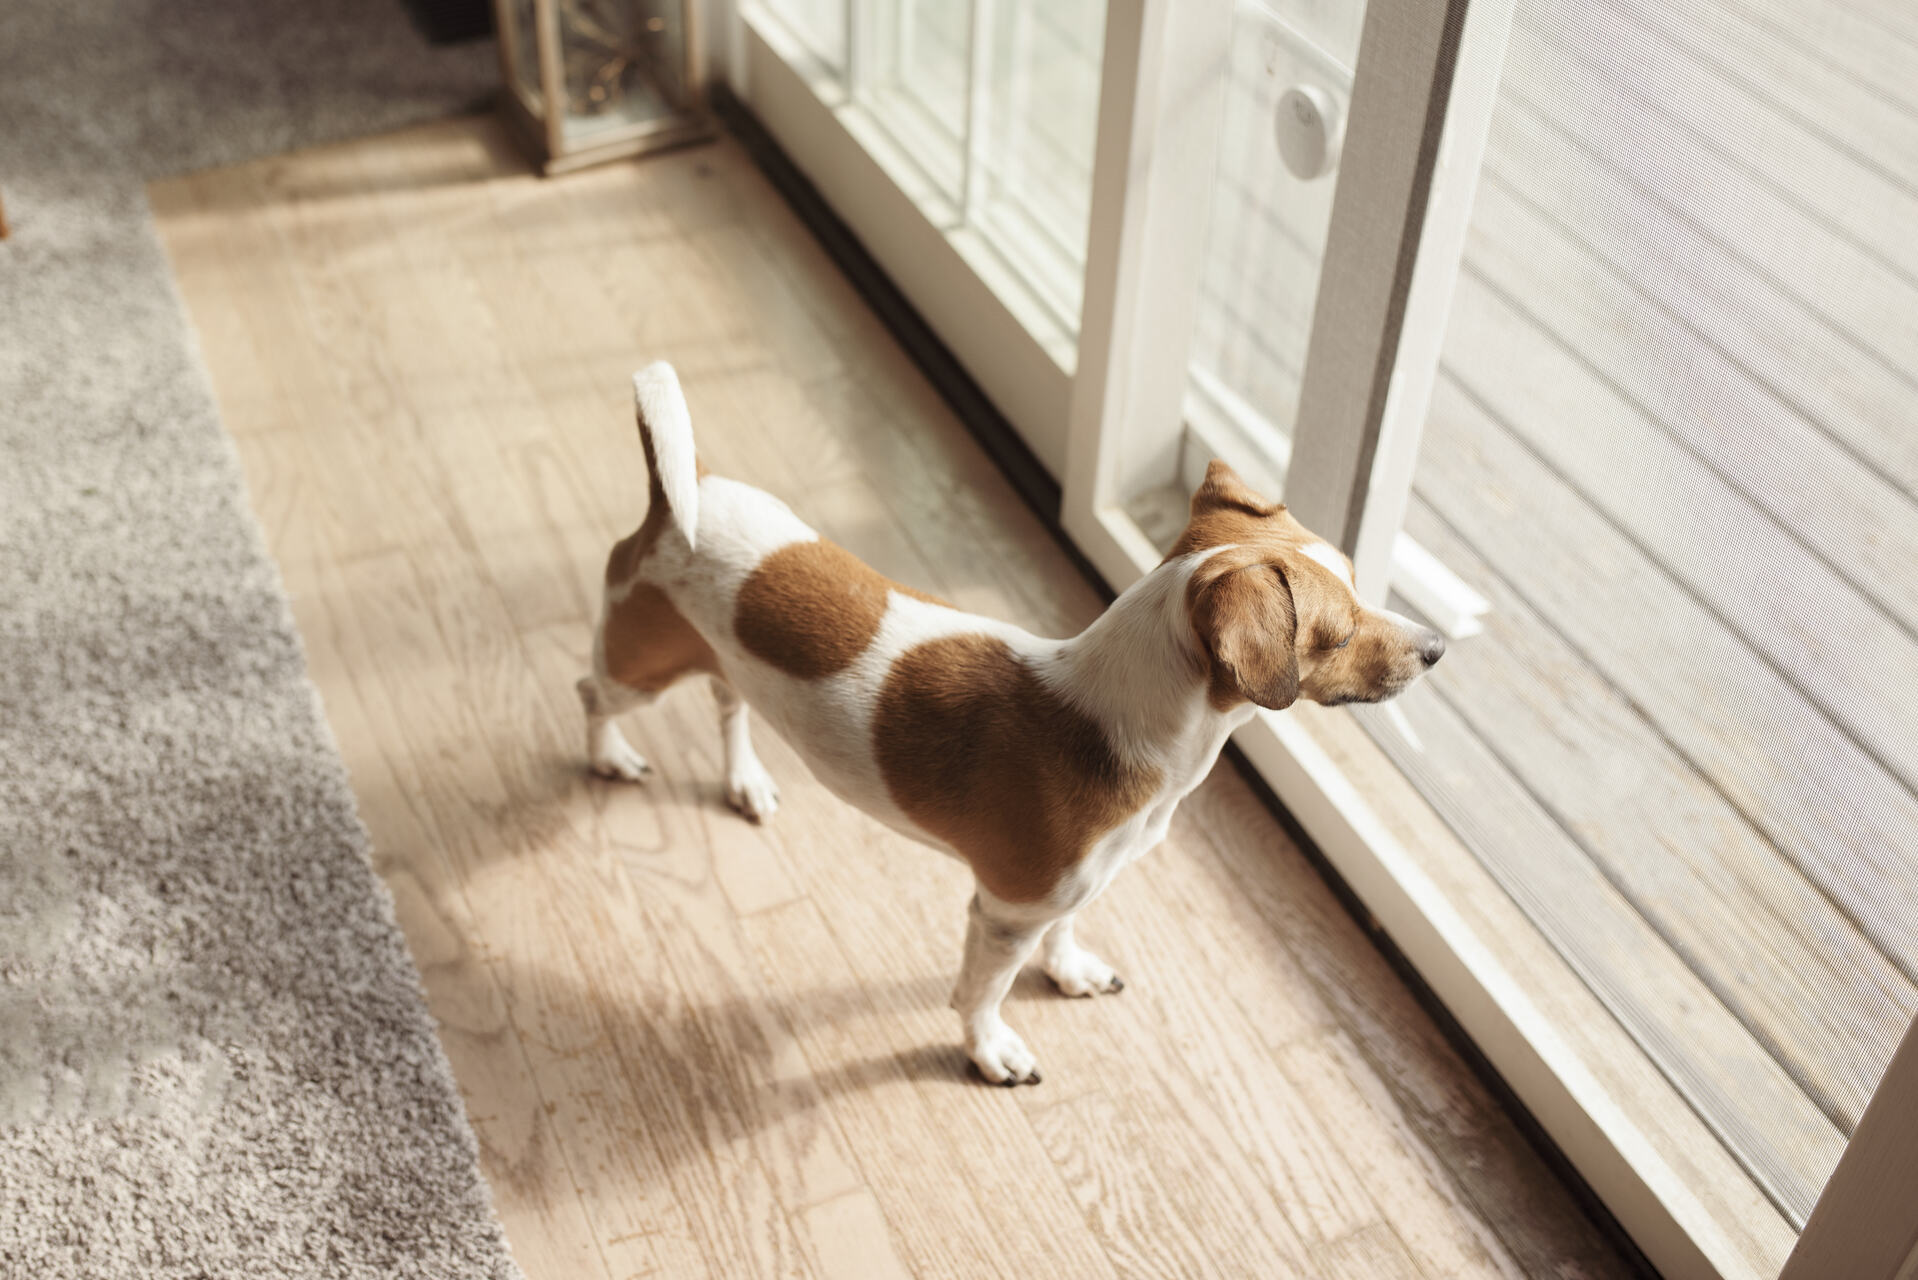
[1191,560,1298,710]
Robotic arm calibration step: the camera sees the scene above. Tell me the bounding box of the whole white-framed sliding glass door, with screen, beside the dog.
[729,0,1918,1280]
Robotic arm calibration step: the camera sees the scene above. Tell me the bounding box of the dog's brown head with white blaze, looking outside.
[1168,462,1444,710]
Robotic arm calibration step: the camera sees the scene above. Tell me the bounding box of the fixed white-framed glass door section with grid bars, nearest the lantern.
[740,0,1107,474]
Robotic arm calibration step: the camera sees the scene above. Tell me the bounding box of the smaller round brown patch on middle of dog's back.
[733,537,946,679]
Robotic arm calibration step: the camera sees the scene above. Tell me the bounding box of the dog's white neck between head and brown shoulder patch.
[1049,557,1243,762]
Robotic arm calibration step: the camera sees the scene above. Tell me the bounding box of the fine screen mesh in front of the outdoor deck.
[1364,0,1918,1224]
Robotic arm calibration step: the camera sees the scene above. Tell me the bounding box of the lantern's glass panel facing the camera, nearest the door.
[558,0,687,144]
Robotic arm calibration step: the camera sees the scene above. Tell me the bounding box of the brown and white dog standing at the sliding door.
[579,365,1444,1084]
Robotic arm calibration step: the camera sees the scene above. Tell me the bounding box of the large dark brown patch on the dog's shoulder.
[873,635,1160,902]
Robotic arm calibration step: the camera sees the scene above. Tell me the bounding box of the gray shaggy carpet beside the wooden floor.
[0,0,518,1280]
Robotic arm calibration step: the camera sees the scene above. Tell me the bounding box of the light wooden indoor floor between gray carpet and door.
[152,121,1630,1280]
